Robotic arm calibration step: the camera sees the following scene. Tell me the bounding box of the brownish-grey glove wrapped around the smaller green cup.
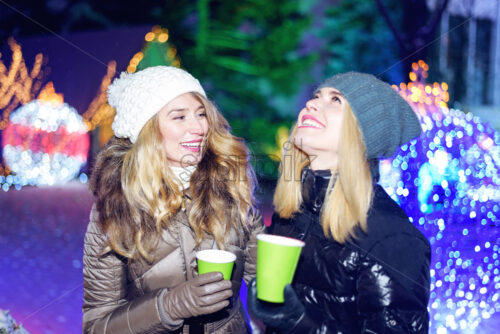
[163,272,233,321]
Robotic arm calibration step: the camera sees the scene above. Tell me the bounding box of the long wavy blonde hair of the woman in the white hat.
[100,93,258,261]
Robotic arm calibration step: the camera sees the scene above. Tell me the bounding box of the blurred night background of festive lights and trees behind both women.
[0,0,500,334]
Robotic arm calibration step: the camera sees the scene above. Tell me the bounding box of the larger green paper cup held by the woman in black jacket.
[257,234,305,303]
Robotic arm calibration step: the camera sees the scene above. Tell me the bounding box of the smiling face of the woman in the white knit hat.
[158,93,208,167]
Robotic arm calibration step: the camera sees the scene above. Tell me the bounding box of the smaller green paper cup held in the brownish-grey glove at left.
[196,249,236,280]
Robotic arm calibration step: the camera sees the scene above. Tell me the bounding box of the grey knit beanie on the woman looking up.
[316,72,422,160]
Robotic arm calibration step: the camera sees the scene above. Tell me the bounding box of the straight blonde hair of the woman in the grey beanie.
[273,103,373,243]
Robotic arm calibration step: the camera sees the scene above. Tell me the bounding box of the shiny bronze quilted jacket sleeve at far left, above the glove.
[83,208,182,334]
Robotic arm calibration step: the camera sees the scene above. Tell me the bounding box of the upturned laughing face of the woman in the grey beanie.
[294,87,347,170]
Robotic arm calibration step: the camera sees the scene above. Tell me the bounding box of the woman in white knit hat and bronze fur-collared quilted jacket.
[83,66,263,334]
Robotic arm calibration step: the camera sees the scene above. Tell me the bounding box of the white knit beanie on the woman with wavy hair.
[108,66,206,143]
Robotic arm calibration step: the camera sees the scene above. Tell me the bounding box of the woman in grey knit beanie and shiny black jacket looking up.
[248,72,430,333]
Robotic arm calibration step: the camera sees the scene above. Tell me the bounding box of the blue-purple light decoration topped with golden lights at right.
[380,64,500,334]
